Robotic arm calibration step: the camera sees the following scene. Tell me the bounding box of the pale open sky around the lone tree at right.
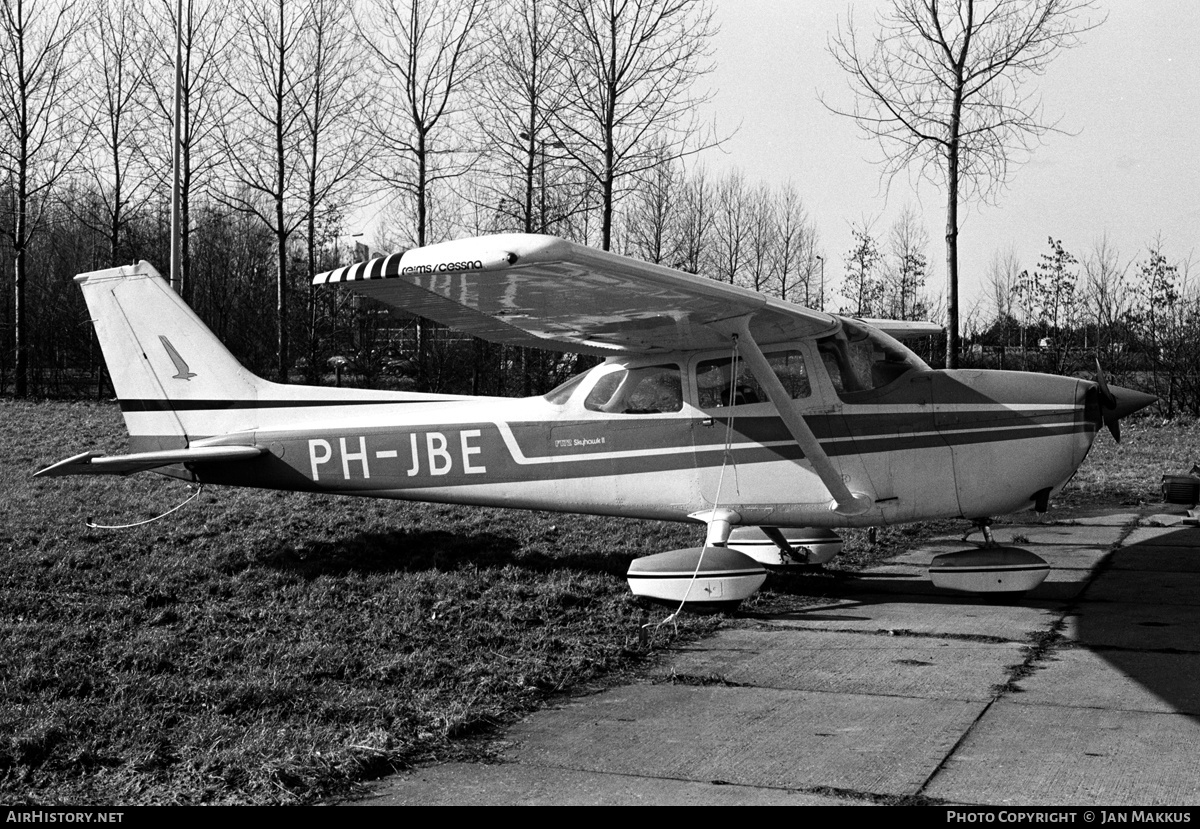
[704,0,1200,311]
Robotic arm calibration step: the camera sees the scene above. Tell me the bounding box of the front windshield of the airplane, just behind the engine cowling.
[817,319,929,403]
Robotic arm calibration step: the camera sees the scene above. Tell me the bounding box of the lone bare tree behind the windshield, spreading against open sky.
[829,0,1098,368]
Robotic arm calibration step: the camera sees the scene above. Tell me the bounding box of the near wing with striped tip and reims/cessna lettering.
[313,234,838,356]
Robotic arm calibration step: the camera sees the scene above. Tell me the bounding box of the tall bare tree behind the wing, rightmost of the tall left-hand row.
[553,0,715,251]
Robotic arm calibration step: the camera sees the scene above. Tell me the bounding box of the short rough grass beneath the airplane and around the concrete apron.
[0,402,1185,804]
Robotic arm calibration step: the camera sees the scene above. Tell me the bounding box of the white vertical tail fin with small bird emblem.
[76,262,271,451]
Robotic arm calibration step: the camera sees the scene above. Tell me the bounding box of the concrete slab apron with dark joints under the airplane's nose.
[364,515,1200,806]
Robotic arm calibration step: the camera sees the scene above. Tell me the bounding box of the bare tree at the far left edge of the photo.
[0,0,86,397]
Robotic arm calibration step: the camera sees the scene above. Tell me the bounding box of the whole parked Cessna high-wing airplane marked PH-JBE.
[37,234,1153,603]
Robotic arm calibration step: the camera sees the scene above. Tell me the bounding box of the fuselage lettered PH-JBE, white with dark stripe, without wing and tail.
[184,326,1098,527]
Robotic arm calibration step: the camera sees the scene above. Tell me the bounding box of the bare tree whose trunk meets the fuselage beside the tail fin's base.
[220,0,312,383]
